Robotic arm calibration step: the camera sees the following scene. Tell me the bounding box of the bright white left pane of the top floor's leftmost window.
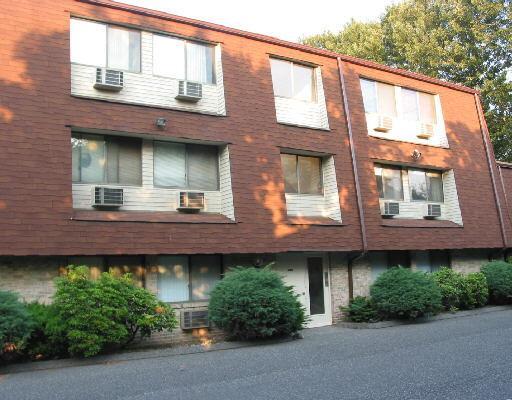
[70,18,107,67]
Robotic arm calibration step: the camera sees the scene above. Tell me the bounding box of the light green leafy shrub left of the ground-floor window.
[53,266,177,357]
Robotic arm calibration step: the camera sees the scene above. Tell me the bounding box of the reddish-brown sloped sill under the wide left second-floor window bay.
[71,210,236,224]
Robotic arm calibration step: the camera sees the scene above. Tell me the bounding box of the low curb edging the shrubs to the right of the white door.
[336,306,512,329]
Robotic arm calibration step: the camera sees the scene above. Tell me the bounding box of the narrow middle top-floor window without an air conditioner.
[270,58,316,102]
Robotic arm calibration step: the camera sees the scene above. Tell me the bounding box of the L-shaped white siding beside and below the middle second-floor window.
[285,156,341,222]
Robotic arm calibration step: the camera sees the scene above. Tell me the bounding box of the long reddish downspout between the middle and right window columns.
[337,57,368,299]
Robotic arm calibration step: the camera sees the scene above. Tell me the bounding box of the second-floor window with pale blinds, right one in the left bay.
[153,142,219,190]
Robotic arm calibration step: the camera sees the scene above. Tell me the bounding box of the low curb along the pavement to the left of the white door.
[0,337,295,376]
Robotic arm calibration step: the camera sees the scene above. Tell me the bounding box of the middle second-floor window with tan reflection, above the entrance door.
[281,154,322,194]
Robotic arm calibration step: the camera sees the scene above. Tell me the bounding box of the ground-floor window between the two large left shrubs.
[157,255,222,302]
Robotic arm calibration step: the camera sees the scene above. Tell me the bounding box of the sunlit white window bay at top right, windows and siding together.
[360,78,449,148]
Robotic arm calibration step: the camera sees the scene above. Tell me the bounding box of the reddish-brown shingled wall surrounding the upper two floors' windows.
[0,0,501,255]
